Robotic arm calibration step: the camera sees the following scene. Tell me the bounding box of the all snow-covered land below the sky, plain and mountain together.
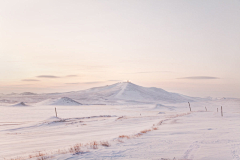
[0,83,240,160]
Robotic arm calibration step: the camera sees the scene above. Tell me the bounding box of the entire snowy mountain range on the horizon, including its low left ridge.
[1,82,204,105]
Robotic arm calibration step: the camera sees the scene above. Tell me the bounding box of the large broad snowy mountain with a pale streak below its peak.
[65,82,200,103]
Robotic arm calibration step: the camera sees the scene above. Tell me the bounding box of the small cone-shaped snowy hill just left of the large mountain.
[37,97,82,106]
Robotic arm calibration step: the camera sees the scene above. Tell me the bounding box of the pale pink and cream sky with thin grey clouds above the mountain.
[0,0,240,98]
